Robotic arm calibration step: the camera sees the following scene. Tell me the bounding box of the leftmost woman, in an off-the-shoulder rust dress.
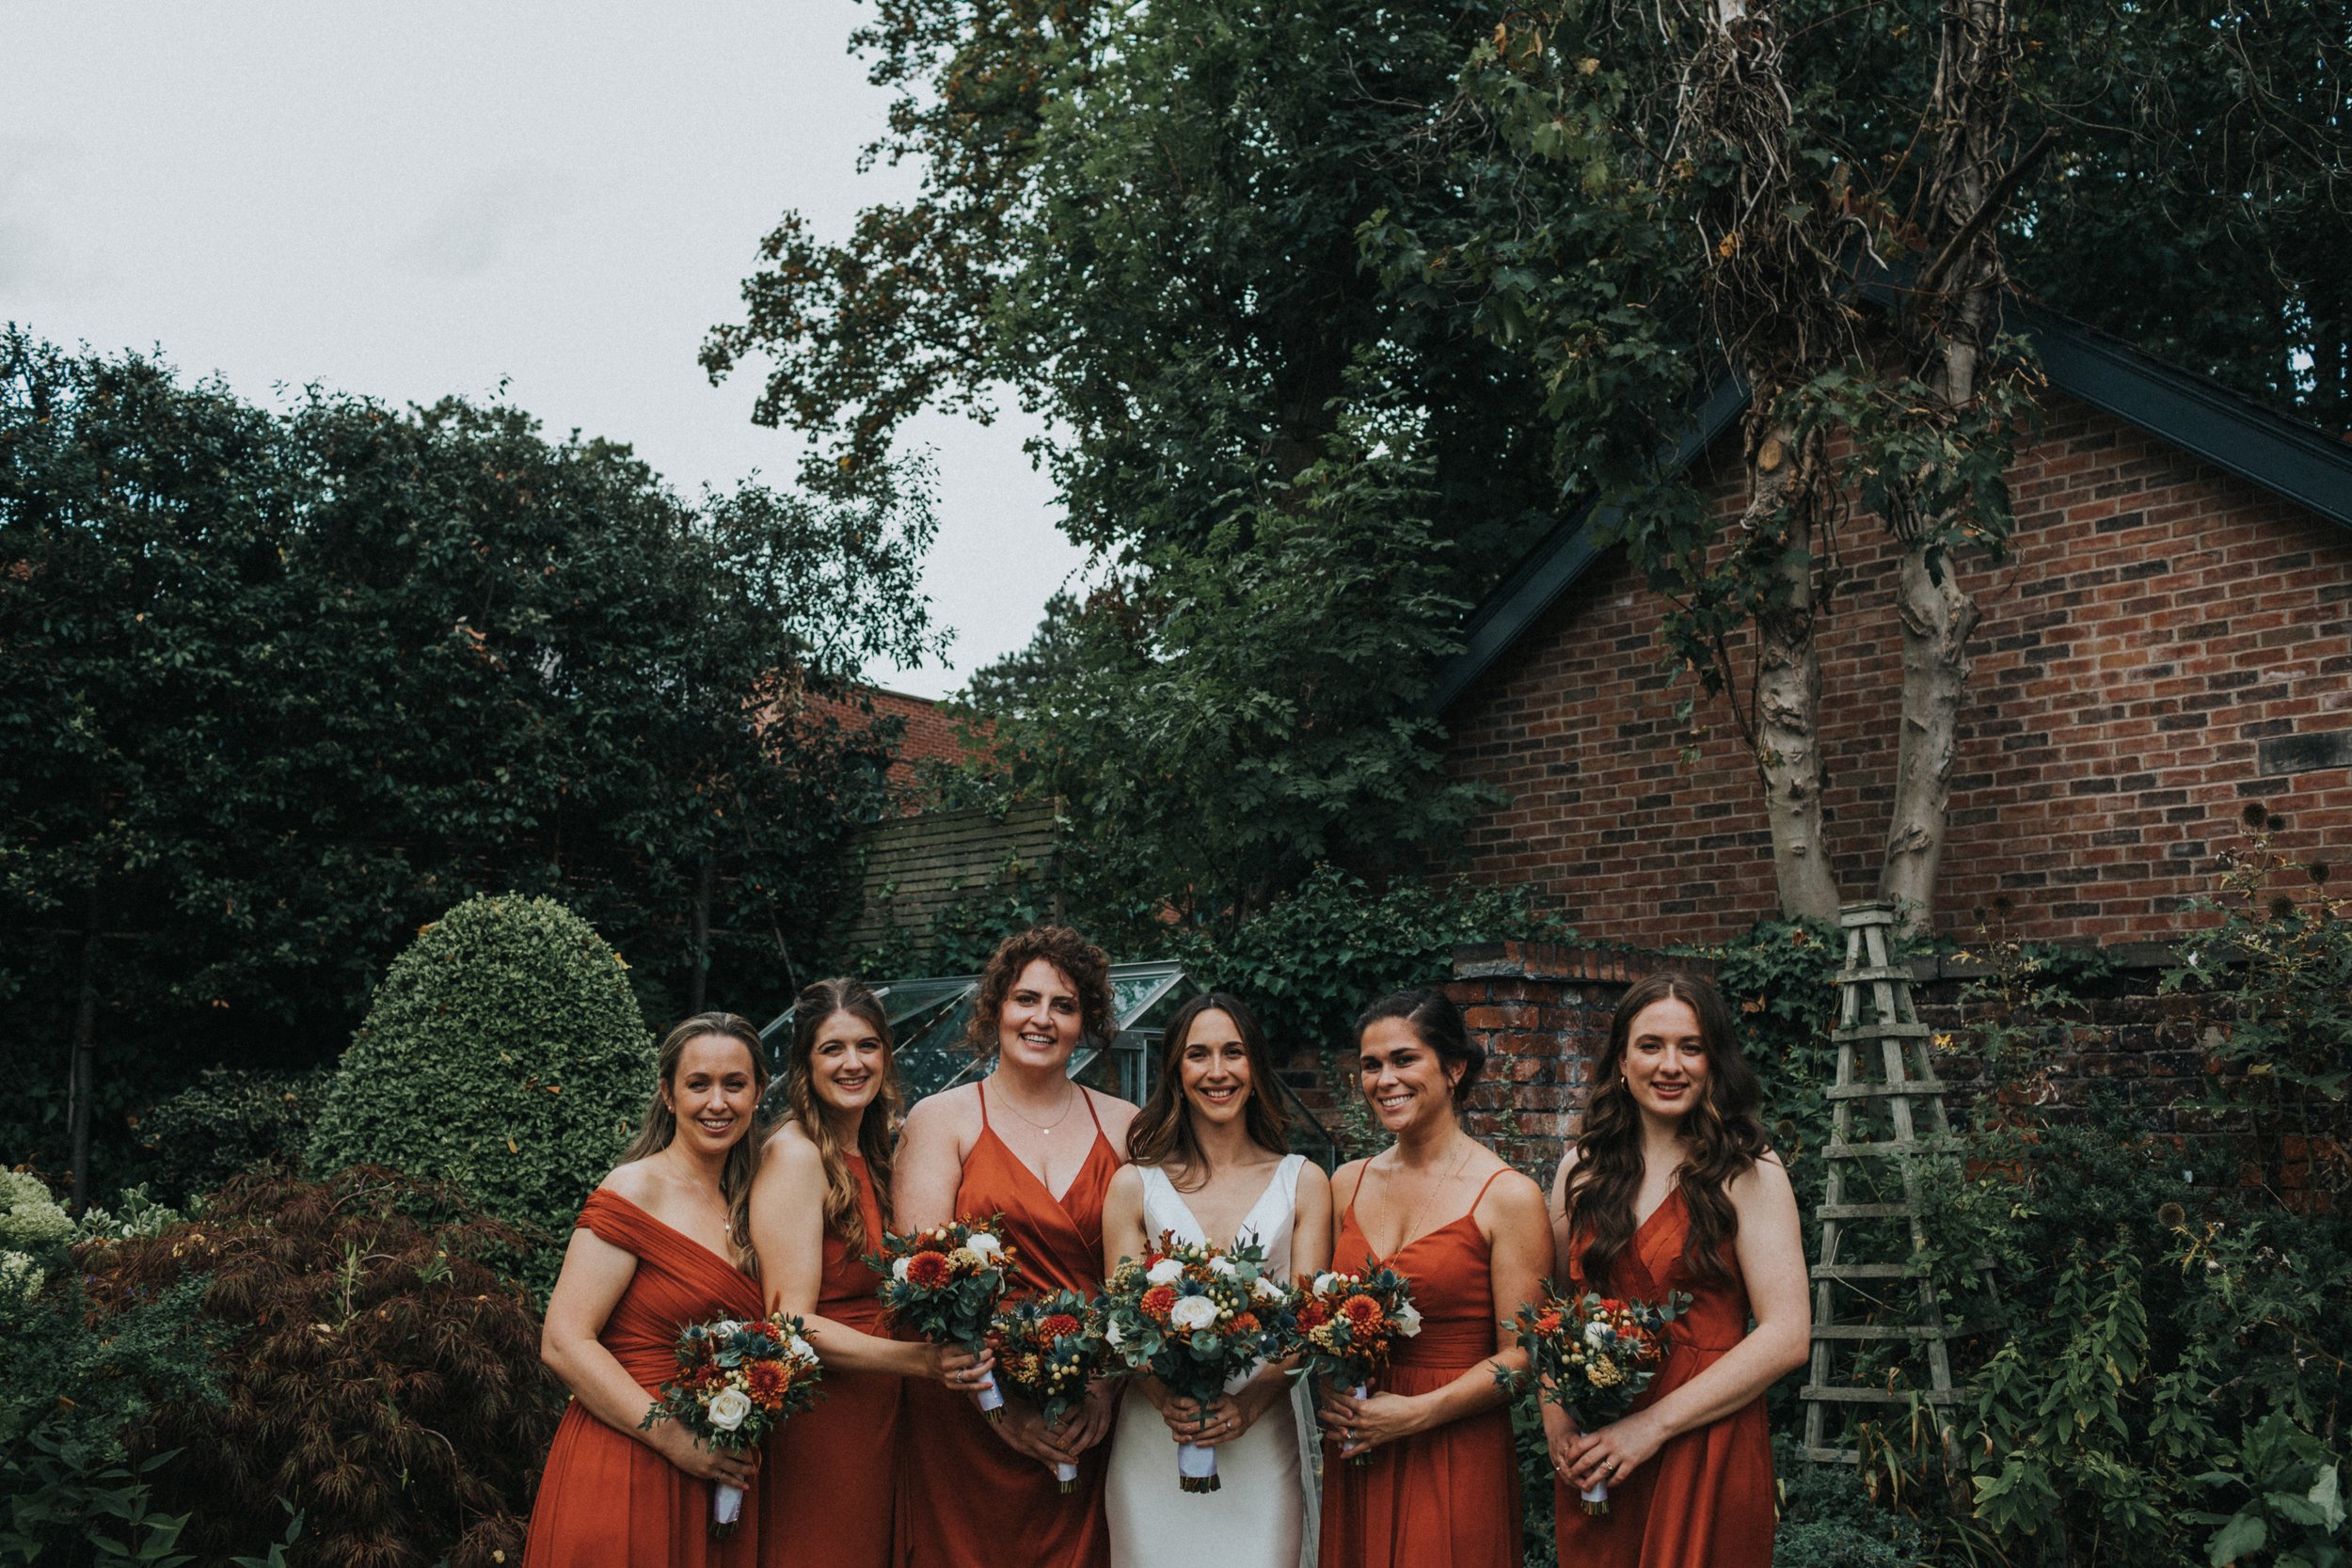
[522,1013,767,1568]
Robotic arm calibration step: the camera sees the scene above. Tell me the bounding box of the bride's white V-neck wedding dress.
[1104,1154,1317,1568]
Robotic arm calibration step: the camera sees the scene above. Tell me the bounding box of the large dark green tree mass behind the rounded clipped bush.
[0,329,931,1199]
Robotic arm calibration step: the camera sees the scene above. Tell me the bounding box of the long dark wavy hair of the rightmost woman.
[1566,971,1767,1286]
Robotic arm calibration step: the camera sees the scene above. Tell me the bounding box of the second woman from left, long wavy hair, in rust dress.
[751,980,983,1568]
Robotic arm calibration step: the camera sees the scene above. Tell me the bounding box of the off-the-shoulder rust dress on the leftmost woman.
[522,1187,760,1568]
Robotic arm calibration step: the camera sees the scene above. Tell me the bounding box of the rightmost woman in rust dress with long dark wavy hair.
[1543,974,1814,1568]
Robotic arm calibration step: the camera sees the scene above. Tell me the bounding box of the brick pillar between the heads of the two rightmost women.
[1447,942,1715,1187]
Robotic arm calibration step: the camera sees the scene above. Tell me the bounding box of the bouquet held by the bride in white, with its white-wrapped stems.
[1104,1232,1287,1493]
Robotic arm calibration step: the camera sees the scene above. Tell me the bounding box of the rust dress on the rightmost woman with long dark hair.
[1552,1187,1776,1568]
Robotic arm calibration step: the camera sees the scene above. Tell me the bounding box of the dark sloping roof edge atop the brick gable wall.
[1433,301,2352,712]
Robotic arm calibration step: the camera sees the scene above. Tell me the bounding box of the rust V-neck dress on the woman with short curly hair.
[898,1084,1120,1568]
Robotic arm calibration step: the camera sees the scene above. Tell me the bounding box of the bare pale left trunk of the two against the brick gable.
[1748,422,1837,919]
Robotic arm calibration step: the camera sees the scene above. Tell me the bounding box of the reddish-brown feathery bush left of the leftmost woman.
[83,1168,560,1568]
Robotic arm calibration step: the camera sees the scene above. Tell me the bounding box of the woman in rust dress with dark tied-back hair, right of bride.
[1320,990,1552,1568]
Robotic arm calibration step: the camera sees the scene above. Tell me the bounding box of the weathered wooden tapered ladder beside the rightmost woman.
[1800,903,1960,1465]
